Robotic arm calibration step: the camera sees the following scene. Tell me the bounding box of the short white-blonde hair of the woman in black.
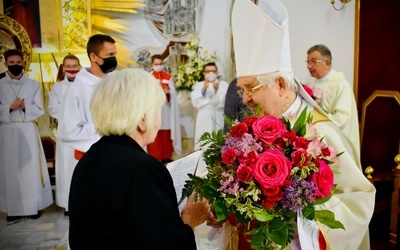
[90,69,165,135]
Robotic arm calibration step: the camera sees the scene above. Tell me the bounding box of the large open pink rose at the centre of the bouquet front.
[252,150,292,188]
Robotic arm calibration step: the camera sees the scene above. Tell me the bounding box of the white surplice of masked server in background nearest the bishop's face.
[190,81,229,149]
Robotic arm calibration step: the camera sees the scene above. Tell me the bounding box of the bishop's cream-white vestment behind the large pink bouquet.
[283,97,375,250]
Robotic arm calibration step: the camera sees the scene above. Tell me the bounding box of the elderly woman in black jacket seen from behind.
[69,69,209,250]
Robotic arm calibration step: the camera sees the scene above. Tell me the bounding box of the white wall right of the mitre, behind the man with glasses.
[281,0,356,84]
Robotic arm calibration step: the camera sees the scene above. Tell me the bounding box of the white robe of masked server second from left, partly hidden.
[48,77,78,210]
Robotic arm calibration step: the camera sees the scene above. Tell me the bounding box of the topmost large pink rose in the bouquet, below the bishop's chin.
[252,115,287,145]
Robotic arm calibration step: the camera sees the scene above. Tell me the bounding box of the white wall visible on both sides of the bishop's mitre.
[200,0,356,84]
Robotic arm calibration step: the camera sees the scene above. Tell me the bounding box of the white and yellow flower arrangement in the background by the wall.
[172,33,218,91]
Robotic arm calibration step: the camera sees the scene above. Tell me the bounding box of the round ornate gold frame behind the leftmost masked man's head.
[0,14,32,73]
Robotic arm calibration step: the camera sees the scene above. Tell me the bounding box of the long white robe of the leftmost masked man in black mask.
[0,74,53,216]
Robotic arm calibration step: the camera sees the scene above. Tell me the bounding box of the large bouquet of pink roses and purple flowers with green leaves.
[183,109,344,249]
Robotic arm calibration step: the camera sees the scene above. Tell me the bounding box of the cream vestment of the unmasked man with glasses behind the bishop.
[307,69,360,161]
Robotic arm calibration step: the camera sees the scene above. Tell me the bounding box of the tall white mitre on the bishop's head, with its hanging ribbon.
[232,0,325,114]
